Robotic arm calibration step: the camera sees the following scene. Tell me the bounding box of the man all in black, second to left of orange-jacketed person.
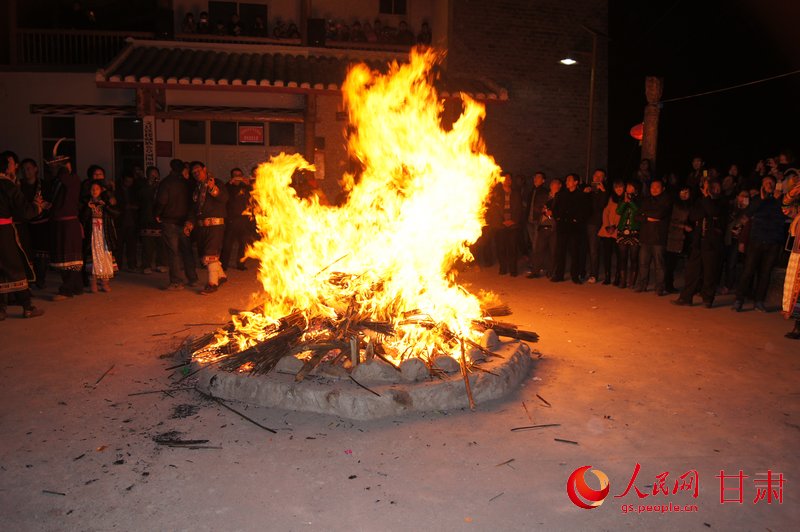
[550,174,588,284]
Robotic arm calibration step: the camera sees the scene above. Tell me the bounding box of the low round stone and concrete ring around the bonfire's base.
[197,340,533,420]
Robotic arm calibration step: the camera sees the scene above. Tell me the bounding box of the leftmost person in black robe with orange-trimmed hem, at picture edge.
[0,151,44,321]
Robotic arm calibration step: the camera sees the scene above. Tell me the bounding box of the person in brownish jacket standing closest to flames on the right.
[492,174,523,277]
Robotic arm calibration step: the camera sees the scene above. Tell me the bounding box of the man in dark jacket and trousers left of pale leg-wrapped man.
[153,159,197,290]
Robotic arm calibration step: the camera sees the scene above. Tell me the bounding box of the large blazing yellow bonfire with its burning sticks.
[193,51,536,386]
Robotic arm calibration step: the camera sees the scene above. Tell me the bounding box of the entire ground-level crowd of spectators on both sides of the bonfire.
[0,147,800,338]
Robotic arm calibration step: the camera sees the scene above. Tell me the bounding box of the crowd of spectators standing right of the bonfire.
[474,151,800,338]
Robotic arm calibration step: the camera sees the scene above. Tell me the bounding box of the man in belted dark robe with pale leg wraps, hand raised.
[191,161,228,295]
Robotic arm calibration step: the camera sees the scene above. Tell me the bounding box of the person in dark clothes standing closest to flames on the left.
[219,168,253,270]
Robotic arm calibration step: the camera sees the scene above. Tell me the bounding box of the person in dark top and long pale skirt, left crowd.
[81,183,119,292]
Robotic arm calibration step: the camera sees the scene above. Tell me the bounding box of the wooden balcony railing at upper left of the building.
[12,28,154,67]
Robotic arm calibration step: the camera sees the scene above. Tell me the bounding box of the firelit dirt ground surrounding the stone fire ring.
[0,269,800,531]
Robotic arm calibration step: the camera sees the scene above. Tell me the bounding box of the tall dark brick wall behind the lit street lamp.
[447,0,608,181]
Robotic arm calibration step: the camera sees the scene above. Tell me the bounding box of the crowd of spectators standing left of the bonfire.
[0,151,256,320]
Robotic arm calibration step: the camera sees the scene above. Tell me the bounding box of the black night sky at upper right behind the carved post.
[609,0,800,181]
